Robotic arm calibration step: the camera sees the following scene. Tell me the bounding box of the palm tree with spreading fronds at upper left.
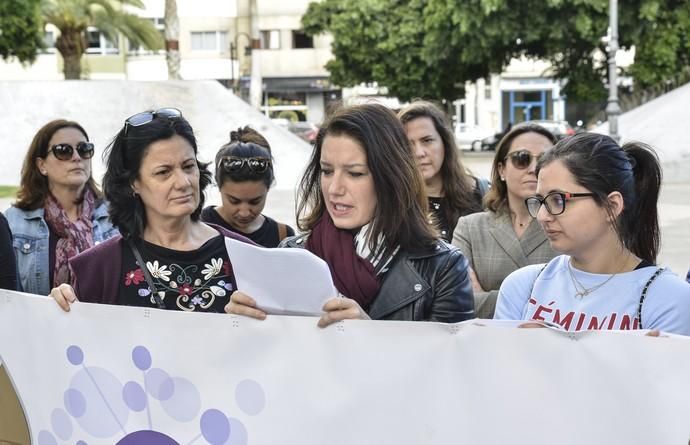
[41,0,163,79]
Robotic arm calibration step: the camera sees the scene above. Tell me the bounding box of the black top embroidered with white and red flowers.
[117,235,237,312]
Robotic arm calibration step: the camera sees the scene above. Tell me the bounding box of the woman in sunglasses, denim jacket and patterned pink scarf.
[5,120,118,295]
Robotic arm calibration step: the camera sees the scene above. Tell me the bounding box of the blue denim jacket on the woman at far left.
[5,202,120,295]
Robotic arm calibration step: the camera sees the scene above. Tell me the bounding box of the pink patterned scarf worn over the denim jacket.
[44,188,95,287]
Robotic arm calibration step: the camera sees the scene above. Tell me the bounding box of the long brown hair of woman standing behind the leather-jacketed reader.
[398,100,481,233]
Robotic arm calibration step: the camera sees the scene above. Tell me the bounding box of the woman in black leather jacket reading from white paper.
[227,104,474,326]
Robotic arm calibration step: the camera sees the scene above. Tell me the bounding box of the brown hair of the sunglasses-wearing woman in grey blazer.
[484,124,556,213]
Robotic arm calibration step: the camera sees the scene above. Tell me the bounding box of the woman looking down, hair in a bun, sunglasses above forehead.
[201,127,295,247]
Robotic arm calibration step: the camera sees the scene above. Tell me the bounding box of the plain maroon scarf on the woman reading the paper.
[306,213,380,310]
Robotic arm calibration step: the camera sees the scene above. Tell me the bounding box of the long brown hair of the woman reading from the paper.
[296,104,436,255]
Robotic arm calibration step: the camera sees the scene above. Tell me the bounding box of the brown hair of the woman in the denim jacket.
[14,119,103,210]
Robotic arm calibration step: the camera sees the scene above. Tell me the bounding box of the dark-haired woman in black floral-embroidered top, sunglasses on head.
[51,108,251,312]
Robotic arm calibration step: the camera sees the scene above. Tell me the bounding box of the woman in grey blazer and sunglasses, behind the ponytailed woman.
[453,124,556,318]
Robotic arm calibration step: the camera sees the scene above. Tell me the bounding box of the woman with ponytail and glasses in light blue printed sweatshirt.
[495,133,690,335]
